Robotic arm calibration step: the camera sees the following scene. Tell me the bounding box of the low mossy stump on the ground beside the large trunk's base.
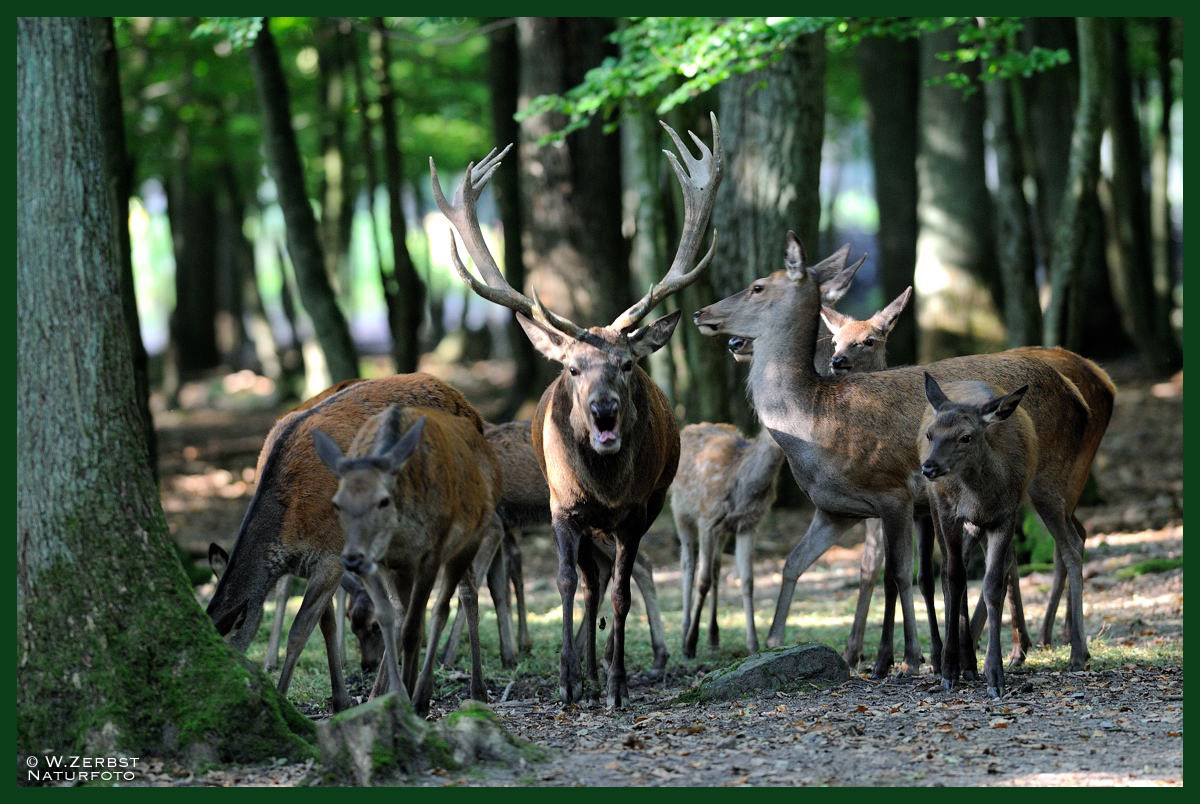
[317,692,544,786]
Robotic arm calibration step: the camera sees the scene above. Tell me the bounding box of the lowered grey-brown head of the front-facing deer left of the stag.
[312,406,425,575]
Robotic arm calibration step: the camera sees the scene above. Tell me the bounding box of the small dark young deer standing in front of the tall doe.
[917,373,1038,697]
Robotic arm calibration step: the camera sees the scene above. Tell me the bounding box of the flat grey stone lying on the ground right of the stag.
[694,642,850,701]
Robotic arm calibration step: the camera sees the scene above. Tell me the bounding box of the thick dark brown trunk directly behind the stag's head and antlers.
[517,17,632,388]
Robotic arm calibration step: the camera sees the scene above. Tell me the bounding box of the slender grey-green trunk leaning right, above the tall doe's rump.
[1043,17,1105,350]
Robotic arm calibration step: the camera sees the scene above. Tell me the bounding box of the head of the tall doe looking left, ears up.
[692,232,866,345]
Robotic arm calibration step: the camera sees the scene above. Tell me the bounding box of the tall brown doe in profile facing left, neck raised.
[694,233,1094,677]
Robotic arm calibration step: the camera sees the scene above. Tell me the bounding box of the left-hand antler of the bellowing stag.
[430,143,587,338]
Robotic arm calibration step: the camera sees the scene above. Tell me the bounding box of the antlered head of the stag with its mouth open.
[430,115,722,455]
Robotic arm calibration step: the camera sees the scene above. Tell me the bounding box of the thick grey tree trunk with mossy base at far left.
[17,18,314,763]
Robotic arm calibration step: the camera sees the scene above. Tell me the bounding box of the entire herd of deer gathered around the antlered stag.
[201,111,1115,713]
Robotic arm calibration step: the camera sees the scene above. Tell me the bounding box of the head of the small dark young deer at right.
[919,372,1030,480]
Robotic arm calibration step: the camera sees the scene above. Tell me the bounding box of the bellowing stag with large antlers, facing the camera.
[430,115,721,708]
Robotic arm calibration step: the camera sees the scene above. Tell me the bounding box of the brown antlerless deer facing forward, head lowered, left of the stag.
[312,406,502,714]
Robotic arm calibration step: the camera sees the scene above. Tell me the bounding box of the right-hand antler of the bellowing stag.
[612,113,725,330]
